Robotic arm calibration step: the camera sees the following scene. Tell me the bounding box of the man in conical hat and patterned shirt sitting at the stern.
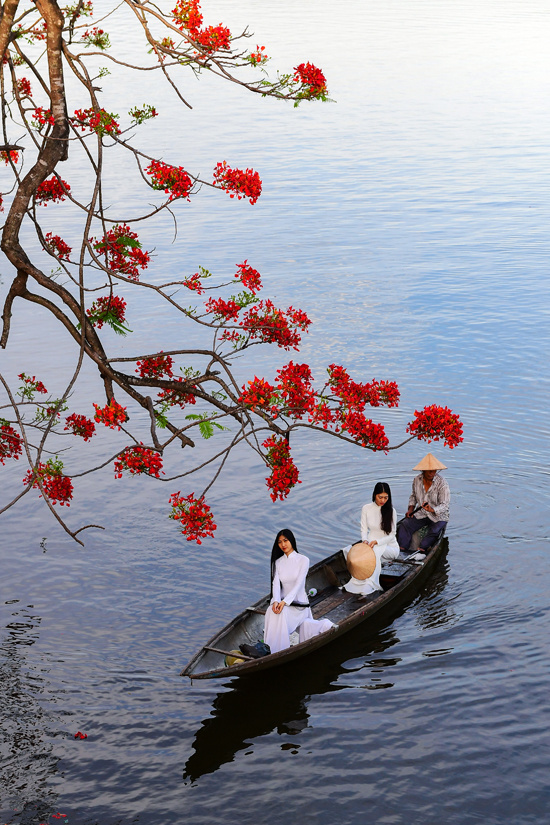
[397,453,451,551]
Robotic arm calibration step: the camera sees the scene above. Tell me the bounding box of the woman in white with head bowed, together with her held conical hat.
[343,481,399,596]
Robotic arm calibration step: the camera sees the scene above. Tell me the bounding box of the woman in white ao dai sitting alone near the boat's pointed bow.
[264,530,334,653]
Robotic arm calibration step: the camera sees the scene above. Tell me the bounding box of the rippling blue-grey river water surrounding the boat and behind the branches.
[0,0,550,825]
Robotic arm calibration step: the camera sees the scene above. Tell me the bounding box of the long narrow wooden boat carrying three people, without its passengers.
[180,529,446,679]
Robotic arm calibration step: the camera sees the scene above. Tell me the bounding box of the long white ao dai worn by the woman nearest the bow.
[264,550,334,653]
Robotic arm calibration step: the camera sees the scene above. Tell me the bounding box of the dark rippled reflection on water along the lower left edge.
[0,608,57,825]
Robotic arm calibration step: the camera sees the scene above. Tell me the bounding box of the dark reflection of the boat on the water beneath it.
[183,546,453,784]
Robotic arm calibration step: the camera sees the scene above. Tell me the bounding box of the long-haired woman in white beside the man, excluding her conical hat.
[343,481,399,596]
